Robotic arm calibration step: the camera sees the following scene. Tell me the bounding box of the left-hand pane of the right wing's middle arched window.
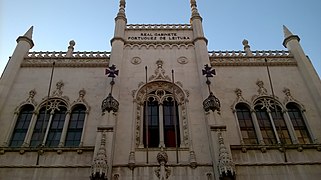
[255,106,277,144]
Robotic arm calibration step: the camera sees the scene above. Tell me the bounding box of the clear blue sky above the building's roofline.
[0,0,321,76]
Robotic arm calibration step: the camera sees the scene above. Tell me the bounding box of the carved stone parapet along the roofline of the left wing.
[21,51,110,67]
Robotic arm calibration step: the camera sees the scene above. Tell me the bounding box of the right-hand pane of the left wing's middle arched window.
[46,107,67,147]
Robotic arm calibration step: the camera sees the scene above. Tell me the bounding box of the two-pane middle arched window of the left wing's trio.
[30,99,67,147]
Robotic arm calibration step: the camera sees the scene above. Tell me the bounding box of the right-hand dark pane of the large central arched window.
[163,98,180,147]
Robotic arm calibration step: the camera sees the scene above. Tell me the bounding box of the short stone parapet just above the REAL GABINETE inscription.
[126,24,192,30]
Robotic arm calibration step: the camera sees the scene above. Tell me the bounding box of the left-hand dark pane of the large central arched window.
[143,98,159,147]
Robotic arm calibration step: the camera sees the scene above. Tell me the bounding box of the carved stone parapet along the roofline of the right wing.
[209,50,297,66]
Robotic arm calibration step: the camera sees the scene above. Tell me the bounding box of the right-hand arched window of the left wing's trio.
[65,105,86,147]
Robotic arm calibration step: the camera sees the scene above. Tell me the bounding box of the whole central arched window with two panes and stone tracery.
[143,89,180,147]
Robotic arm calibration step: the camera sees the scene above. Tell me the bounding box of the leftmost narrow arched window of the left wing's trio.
[9,104,34,147]
